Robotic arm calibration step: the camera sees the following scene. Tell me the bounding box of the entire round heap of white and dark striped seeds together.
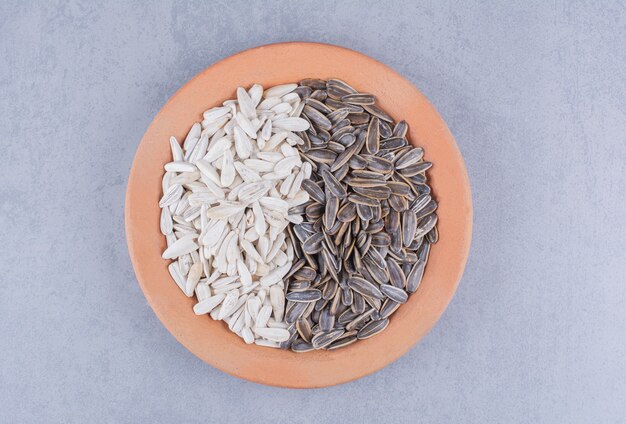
[159,79,438,352]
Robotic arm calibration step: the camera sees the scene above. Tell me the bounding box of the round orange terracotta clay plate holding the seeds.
[126,43,472,388]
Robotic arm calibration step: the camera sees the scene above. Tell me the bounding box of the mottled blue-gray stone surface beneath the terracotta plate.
[0,0,626,423]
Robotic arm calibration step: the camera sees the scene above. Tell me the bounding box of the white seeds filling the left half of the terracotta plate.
[159,84,312,347]
